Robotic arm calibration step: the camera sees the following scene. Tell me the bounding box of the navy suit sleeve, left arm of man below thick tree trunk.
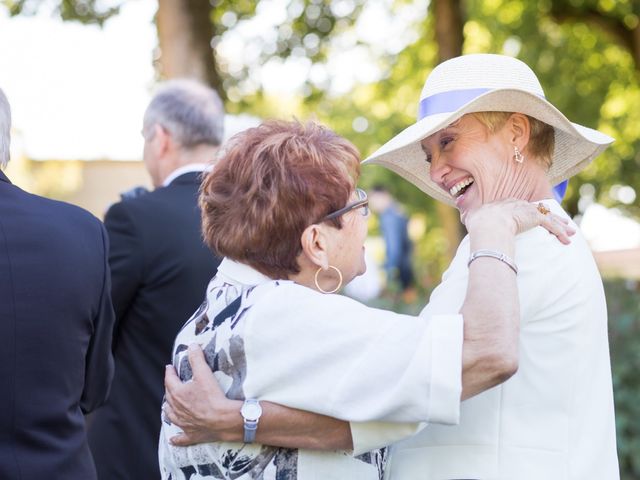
[104,202,143,347]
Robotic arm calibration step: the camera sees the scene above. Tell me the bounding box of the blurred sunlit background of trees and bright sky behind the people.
[0,0,640,479]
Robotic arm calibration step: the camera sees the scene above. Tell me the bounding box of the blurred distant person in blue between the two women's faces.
[369,185,416,303]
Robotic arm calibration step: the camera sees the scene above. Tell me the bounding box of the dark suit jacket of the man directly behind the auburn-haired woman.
[89,173,219,480]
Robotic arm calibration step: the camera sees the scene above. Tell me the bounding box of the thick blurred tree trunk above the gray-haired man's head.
[156,0,225,98]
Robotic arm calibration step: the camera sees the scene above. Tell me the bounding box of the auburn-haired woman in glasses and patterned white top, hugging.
[159,121,572,480]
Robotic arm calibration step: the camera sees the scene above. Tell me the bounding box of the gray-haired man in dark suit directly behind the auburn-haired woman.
[89,80,224,480]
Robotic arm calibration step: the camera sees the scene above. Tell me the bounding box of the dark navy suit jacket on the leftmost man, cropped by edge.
[0,172,114,480]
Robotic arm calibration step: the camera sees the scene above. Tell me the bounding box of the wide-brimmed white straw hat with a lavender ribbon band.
[363,54,613,204]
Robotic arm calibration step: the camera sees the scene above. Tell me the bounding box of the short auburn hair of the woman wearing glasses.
[200,120,360,278]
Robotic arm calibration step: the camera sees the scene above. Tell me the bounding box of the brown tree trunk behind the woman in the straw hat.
[432,0,465,258]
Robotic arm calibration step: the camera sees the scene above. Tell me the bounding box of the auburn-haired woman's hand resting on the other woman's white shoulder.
[465,199,576,245]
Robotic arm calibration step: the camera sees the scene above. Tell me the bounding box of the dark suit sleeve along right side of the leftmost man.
[80,220,115,413]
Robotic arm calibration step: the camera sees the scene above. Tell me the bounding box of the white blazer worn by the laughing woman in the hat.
[386,200,619,480]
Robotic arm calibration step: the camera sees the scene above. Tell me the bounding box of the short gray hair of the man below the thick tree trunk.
[143,80,224,148]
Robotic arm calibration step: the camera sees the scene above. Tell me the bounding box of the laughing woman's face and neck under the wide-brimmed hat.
[421,115,527,218]
